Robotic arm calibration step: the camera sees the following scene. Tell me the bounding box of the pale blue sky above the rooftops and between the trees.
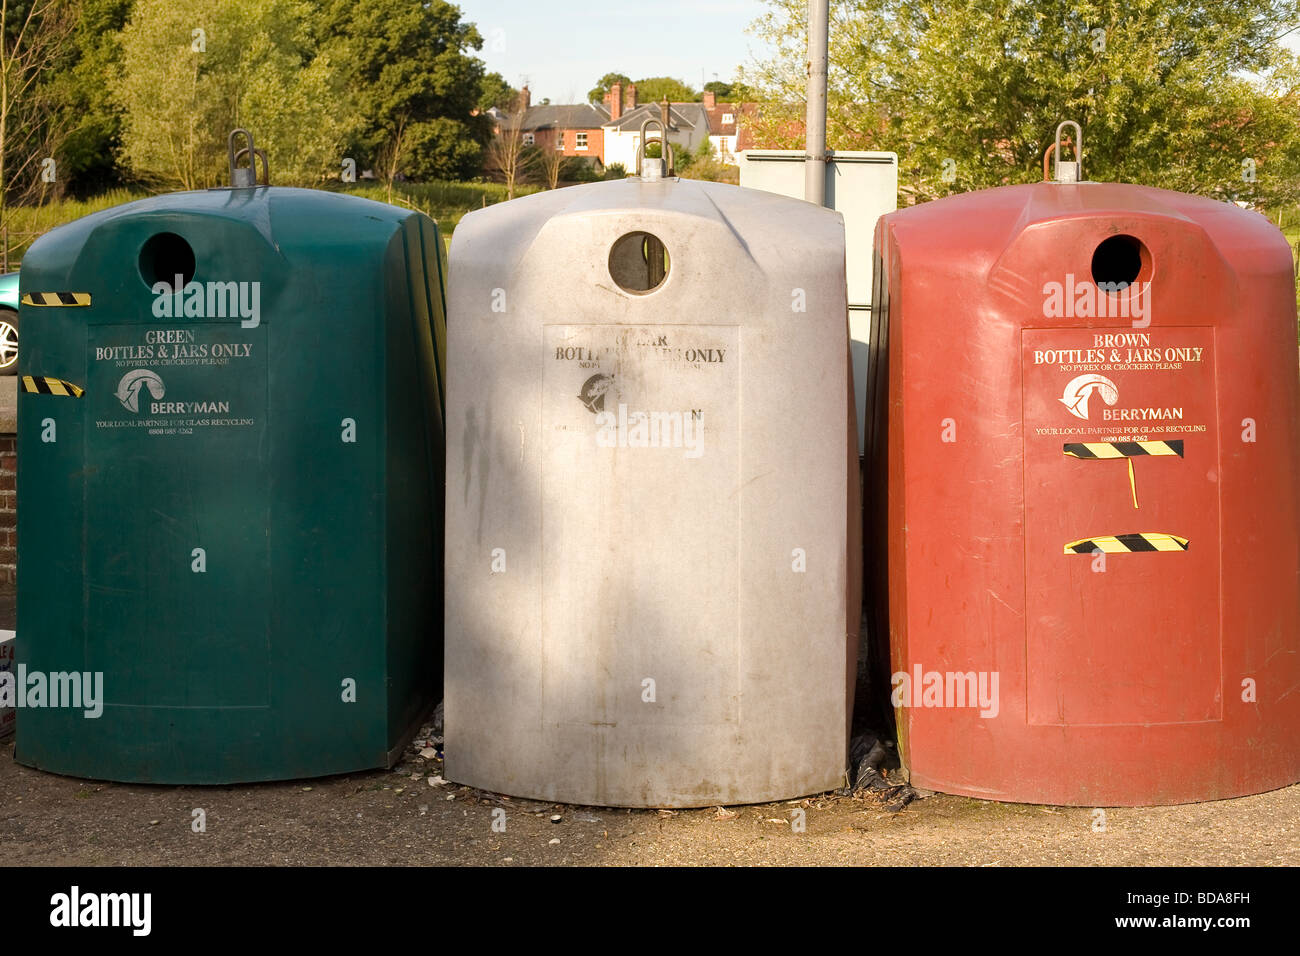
[452,0,766,103]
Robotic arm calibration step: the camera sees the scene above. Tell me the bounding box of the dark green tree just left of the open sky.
[321,0,504,179]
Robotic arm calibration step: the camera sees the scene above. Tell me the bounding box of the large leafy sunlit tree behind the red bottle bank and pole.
[742,0,1300,203]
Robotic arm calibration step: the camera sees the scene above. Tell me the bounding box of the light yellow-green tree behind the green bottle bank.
[114,0,354,189]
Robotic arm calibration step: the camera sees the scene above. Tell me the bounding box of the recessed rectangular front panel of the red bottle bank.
[1022,326,1223,726]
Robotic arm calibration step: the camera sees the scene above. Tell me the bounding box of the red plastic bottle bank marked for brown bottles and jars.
[867,183,1300,806]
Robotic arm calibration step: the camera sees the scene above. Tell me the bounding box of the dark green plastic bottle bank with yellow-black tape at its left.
[16,186,446,783]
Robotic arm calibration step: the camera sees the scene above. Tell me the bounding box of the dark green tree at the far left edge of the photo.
[0,0,77,219]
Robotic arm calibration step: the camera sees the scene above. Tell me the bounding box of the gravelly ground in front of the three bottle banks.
[0,741,1300,866]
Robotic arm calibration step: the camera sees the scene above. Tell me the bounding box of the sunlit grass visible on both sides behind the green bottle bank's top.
[4,182,538,271]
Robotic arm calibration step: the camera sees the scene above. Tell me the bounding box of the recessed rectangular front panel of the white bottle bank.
[541,325,741,724]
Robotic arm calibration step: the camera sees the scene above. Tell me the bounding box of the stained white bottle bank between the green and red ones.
[445,178,862,806]
